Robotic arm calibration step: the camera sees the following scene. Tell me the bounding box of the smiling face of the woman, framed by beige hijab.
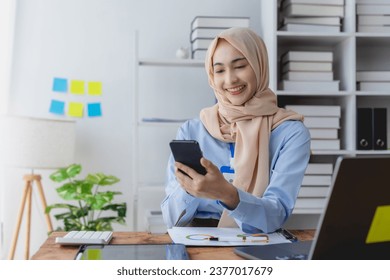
[213,39,257,105]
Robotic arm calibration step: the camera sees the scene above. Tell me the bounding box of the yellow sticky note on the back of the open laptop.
[366,205,390,243]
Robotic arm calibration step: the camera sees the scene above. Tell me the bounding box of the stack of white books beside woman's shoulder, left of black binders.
[285,105,341,150]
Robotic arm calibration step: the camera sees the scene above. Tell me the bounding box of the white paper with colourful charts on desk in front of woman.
[168,227,291,246]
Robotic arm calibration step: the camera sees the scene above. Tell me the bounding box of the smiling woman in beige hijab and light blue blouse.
[161,28,310,233]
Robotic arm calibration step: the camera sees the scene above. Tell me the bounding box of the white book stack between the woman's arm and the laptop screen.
[295,163,333,209]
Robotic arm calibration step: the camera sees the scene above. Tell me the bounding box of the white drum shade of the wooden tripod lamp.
[0,116,76,169]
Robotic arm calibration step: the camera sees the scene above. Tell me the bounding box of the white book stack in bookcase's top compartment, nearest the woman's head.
[279,0,344,32]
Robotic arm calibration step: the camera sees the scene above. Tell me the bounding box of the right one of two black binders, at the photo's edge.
[372,108,387,150]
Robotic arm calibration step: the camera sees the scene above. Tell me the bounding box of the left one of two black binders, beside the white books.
[356,108,373,150]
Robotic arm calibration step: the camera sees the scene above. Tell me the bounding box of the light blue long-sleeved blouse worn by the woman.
[161,119,310,233]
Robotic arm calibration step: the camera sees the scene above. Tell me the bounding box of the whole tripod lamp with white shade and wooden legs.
[0,116,75,259]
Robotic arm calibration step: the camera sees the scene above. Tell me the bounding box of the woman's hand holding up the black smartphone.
[175,158,239,209]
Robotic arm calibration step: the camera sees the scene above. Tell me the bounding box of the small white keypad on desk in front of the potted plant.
[56,231,112,245]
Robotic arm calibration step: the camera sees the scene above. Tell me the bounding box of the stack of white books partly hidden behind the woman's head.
[190,16,249,59]
